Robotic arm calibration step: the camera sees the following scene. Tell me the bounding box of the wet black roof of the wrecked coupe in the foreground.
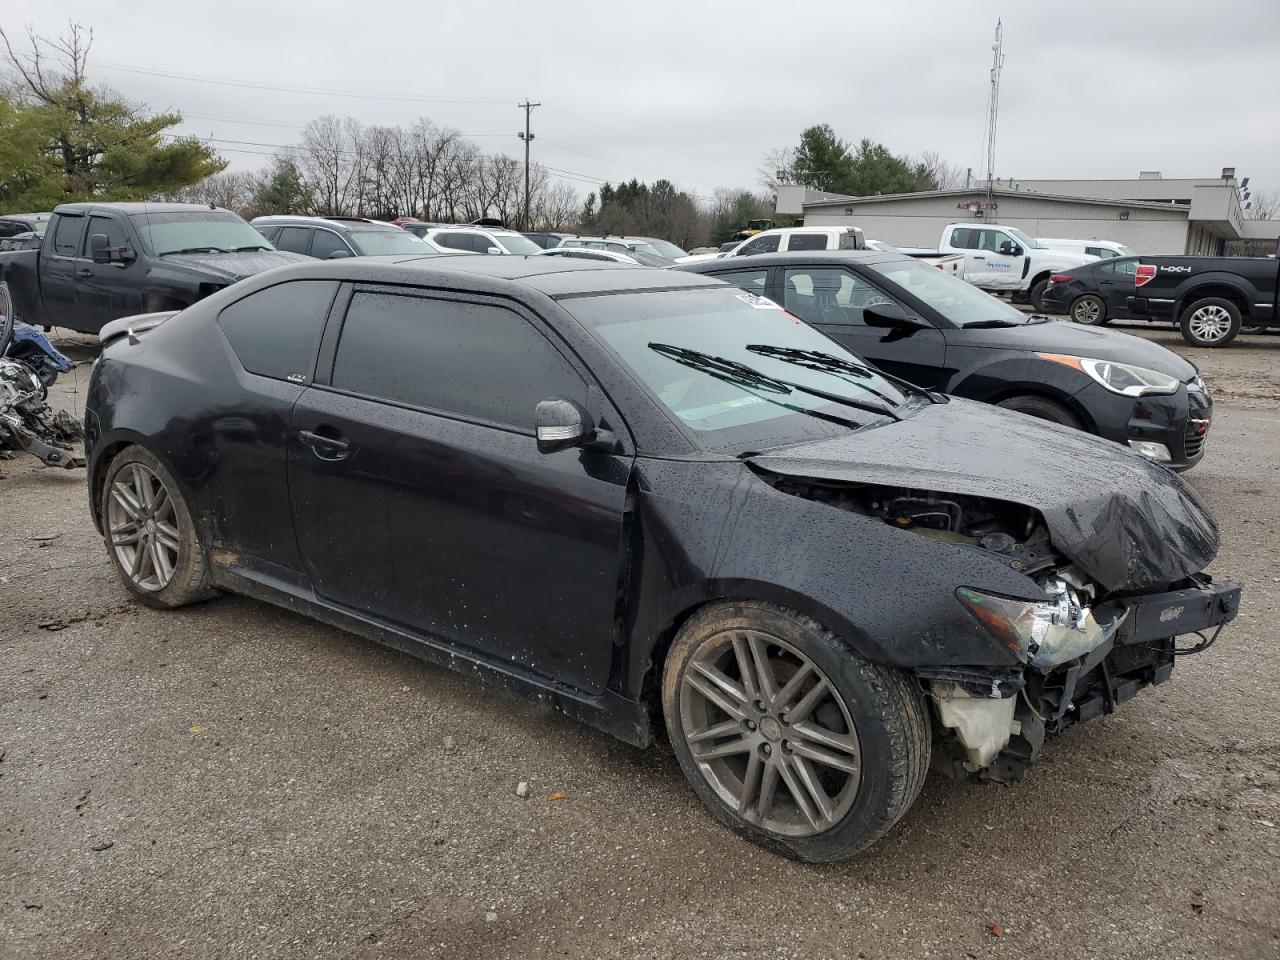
[252,253,722,298]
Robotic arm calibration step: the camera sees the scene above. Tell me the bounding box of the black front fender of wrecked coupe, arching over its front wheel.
[618,460,1043,698]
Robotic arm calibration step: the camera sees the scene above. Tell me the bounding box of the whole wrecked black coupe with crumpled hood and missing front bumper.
[87,256,1238,860]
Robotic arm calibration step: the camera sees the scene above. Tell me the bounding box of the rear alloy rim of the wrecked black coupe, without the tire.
[106,463,180,593]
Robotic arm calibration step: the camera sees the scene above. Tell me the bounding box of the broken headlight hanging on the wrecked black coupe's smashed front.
[956,577,1114,669]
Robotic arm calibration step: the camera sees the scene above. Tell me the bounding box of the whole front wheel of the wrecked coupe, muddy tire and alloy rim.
[662,600,931,863]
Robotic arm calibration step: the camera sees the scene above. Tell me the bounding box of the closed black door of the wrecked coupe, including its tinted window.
[289,287,631,691]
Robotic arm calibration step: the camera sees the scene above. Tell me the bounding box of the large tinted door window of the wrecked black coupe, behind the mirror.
[333,292,586,430]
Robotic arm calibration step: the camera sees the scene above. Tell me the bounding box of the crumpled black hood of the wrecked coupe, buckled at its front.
[751,398,1219,590]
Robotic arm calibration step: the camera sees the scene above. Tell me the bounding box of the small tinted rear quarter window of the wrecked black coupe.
[218,280,338,381]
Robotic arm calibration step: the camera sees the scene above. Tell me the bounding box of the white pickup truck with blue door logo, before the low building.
[904,223,1098,310]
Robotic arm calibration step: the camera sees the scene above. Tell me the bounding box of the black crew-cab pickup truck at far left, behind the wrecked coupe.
[0,204,308,333]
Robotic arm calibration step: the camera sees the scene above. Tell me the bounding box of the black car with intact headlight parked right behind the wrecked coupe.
[673,251,1212,470]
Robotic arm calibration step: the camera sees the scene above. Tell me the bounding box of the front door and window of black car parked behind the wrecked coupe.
[772,265,948,389]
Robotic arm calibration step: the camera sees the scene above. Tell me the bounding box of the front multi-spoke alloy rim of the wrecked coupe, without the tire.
[680,630,861,837]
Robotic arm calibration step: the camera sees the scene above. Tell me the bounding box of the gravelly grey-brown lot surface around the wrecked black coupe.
[0,329,1280,960]
